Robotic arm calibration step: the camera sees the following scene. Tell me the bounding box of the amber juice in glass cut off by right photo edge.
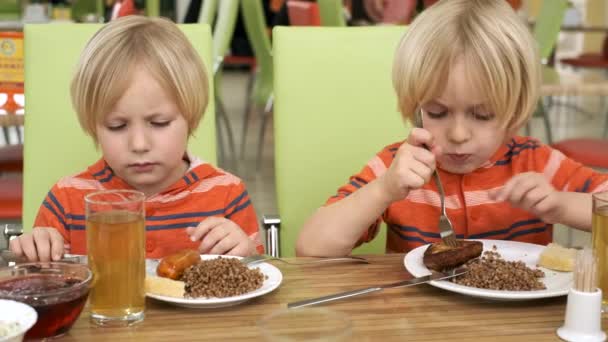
[592,206,608,312]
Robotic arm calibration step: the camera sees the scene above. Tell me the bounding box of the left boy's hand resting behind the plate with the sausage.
[186,217,257,256]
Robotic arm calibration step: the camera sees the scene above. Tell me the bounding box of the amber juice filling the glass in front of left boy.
[87,211,146,319]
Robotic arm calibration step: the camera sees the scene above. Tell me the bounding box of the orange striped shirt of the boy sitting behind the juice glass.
[34,156,264,258]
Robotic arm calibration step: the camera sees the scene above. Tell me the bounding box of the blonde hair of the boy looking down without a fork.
[71,16,208,140]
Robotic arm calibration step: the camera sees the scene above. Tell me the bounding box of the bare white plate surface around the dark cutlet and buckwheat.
[403,240,572,300]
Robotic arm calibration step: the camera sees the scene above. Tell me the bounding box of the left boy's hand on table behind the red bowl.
[9,227,64,261]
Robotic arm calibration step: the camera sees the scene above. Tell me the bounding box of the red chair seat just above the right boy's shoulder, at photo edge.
[551,138,608,169]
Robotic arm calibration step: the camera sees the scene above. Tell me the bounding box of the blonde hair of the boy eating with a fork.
[393,0,540,131]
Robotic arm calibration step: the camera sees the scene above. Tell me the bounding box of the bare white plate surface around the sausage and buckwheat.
[146,255,283,309]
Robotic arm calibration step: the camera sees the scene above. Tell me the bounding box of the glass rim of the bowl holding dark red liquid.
[0,261,93,300]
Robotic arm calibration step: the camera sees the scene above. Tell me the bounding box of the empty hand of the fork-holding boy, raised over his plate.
[494,172,565,223]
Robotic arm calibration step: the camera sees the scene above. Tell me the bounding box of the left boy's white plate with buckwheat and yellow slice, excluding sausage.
[146,255,283,309]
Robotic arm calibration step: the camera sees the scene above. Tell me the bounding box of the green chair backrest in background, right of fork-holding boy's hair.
[533,0,568,61]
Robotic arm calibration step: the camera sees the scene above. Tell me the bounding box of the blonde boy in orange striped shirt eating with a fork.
[296,0,608,256]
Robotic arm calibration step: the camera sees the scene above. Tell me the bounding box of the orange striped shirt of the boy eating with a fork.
[326,137,608,252]
